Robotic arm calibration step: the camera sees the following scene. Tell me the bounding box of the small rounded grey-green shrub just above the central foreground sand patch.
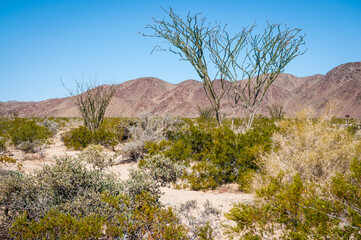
[138,154,185,186]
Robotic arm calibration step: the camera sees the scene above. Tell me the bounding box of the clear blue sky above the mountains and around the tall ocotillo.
[0,0,361,101]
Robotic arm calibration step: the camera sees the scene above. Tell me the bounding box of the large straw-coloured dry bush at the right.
[253,109,360,189]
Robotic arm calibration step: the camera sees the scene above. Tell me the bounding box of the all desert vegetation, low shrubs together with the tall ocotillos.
[0,9,361,240]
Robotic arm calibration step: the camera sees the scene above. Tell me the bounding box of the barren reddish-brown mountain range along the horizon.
[0,62,361,118]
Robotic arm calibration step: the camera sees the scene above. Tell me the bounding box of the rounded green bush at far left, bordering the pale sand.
[9,118,51,152]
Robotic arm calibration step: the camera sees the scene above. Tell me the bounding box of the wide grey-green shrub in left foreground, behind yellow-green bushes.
[0,157,121,238]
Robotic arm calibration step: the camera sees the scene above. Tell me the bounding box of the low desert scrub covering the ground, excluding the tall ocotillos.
[0,110,361,239]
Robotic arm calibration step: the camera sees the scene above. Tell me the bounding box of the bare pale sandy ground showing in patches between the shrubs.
[1,132,254,239]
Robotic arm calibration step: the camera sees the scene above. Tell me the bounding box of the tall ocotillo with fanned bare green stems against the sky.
[144,8,305,130]
